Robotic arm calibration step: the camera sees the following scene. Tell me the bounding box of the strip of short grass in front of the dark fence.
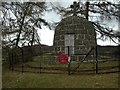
[2,69,118,88]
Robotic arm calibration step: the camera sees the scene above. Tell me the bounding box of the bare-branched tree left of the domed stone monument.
[0,2,49,47]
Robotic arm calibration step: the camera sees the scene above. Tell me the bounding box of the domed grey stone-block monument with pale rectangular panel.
[54,1,97,60]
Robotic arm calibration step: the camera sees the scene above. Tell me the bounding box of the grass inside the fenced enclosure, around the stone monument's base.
[15,55,119,74]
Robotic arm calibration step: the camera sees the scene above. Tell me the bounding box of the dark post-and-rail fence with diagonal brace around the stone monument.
[2,45,120,75]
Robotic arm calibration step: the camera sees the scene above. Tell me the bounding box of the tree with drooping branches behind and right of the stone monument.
[51,1,120,44]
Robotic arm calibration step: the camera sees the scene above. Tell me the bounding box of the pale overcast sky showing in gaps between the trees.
[38,0,118,46]
